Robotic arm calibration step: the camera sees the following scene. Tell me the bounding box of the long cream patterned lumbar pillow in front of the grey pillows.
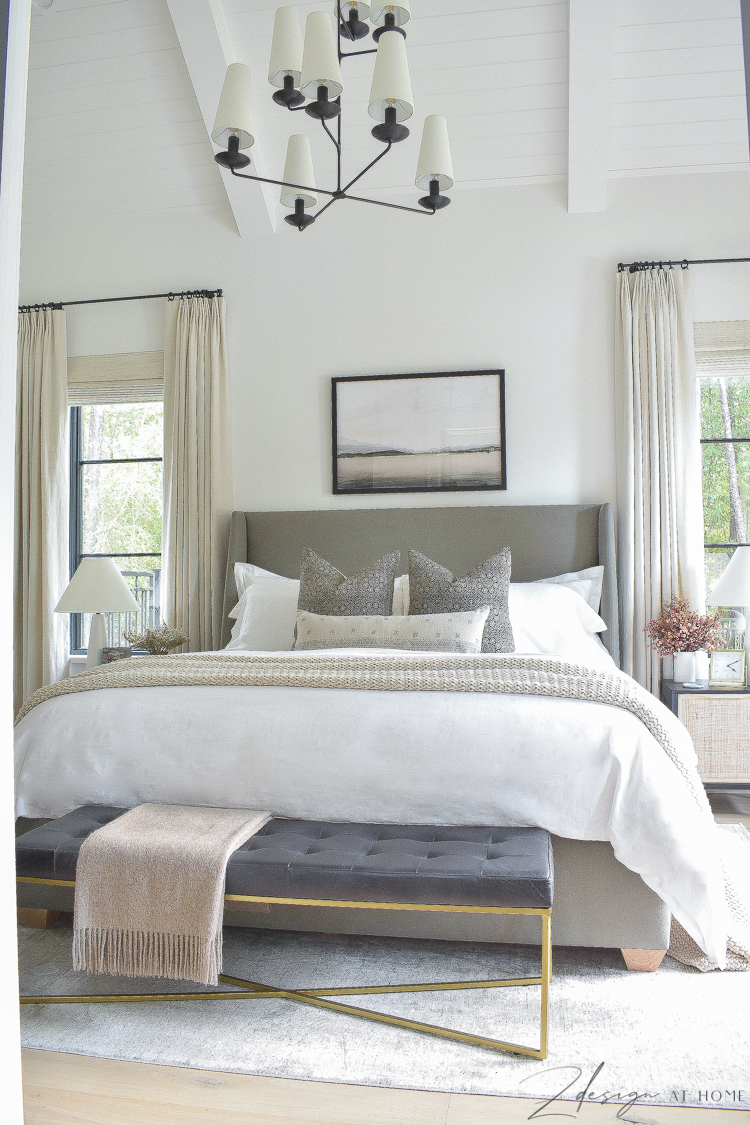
[295,605,489,653]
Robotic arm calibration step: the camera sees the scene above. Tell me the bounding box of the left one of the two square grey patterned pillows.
[297,547,401,617]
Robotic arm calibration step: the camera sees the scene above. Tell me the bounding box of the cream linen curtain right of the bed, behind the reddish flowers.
[616,269,705,693]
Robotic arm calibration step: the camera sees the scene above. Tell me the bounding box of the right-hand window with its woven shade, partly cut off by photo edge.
[695,321,750,592]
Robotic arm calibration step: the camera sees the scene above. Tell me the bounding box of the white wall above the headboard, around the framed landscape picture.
[16,173,750,510]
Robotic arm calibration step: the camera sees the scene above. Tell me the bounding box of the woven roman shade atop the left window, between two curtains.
[67,351,164,406]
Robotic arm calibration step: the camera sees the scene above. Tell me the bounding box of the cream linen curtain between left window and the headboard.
[162,297,232,651]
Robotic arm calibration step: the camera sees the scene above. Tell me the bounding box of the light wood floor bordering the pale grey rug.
[24,794,750,1125]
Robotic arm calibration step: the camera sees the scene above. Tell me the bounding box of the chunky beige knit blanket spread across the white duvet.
[16,650,750,970]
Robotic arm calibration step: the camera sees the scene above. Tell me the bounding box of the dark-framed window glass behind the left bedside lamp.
[70,402,164,651]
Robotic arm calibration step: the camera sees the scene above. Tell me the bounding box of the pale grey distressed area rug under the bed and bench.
[19,916,750,1112]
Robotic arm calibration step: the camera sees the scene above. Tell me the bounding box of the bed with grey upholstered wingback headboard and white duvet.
[17,505,721,952]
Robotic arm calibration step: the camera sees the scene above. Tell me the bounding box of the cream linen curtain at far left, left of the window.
[13,308,70,711]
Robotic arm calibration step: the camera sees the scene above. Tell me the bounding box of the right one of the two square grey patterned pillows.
[409,547,515,653]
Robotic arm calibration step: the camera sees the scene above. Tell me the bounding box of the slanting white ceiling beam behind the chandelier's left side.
[166,0,275,239]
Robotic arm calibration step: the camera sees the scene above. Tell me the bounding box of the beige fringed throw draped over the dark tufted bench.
[73,804,271,984]
